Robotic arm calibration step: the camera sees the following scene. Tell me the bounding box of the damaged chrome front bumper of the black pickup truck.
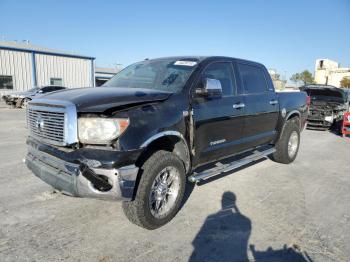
[25,139,139,201]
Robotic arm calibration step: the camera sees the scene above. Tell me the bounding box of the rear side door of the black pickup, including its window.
[237,62,279,149]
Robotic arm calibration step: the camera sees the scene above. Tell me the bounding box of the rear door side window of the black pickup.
[238,64,268,94]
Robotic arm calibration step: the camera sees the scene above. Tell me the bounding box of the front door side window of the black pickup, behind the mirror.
[202,62,235,96]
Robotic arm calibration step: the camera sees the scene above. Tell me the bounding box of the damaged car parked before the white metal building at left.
[2,86,65,108]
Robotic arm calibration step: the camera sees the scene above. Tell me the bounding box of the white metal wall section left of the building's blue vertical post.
[0,50,33,93]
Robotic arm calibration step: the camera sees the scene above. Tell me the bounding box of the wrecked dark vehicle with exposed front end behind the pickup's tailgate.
[300,85,350,133]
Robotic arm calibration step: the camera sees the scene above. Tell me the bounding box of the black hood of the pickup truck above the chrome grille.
[40,87,172,113]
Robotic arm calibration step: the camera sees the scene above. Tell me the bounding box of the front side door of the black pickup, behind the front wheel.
[193,62,244,166]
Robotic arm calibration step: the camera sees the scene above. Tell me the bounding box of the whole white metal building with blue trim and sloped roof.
[0,41,95,95]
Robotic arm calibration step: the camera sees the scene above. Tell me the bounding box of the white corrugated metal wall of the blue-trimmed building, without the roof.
[0,49,95,96]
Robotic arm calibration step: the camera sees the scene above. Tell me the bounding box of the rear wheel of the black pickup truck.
[272,120,300,164]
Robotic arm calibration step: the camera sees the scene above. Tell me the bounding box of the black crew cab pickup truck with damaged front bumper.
[25,57,308,229]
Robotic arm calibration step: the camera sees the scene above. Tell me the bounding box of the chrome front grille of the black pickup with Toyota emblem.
[27,108,65,145]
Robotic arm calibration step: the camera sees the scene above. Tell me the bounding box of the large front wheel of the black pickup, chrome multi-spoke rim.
[122,150,186,230]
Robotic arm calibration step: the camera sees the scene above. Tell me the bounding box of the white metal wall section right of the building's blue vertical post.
[35,54,93,88]
